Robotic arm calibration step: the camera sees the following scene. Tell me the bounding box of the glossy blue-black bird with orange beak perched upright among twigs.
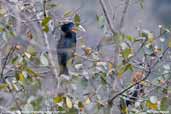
[57,22,77,75]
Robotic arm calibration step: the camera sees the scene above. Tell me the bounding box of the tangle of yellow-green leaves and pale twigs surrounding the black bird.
[0,0,171,114]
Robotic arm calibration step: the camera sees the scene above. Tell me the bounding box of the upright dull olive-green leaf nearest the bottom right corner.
[160,97,169,111]
